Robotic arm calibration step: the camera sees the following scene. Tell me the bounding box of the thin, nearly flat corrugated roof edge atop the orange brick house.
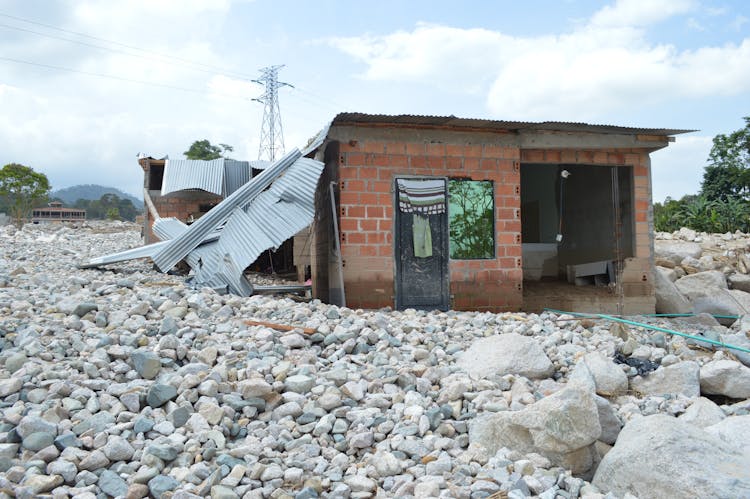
[331,113,696,135]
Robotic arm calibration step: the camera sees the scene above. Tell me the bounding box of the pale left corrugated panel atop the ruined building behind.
[161,158,224,196]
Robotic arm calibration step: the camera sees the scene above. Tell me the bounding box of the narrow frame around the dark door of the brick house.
[391,175,451,310]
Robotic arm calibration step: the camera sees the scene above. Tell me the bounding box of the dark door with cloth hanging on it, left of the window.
[394,177,450,310]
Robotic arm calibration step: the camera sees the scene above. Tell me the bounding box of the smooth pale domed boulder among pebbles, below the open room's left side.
[457,333,555,379]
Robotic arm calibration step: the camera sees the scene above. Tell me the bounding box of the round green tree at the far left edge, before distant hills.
[0,163,50,224]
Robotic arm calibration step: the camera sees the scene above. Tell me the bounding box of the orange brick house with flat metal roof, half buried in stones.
[311,113,687,314]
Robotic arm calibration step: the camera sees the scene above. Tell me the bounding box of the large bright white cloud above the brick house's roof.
[330,0,750,121]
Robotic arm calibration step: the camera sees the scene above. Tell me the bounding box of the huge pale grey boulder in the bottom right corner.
[592,414,750,499]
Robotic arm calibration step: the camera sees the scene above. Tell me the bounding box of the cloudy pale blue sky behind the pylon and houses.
[0,0,750,201]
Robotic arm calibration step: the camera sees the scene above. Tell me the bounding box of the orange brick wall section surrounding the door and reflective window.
[339,140,523,311]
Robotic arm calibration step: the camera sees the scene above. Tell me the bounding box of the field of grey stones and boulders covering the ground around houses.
[0,222,750,499]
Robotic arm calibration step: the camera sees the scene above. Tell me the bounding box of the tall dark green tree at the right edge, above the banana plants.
[701,116,750,201]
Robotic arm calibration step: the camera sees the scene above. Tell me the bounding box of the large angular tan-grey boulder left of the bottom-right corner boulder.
[469,386,602,473]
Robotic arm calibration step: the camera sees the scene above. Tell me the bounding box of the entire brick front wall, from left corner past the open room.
[320,126,655,313]
